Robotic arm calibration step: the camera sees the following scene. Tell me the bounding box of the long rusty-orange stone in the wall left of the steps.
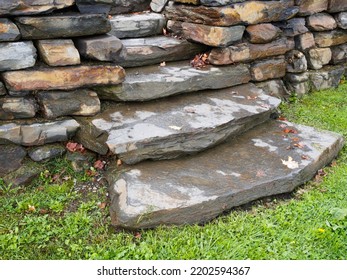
[2,65,125,91]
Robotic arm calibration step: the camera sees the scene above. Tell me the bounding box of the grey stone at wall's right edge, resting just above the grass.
[310,66,345,91]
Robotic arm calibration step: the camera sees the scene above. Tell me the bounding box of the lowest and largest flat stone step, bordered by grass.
[108,121,344,229]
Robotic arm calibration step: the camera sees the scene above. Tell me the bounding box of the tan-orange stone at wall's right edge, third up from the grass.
[314,29,347,48]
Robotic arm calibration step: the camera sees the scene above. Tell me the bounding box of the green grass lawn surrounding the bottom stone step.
[0,84,347,260]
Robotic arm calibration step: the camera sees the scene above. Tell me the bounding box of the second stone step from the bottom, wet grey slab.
[77,84,280,164]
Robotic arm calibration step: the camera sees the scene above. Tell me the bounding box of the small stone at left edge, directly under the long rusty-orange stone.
[0,97,37,120]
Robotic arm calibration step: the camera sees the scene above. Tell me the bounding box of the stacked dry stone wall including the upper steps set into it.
[0,0,347,186]
